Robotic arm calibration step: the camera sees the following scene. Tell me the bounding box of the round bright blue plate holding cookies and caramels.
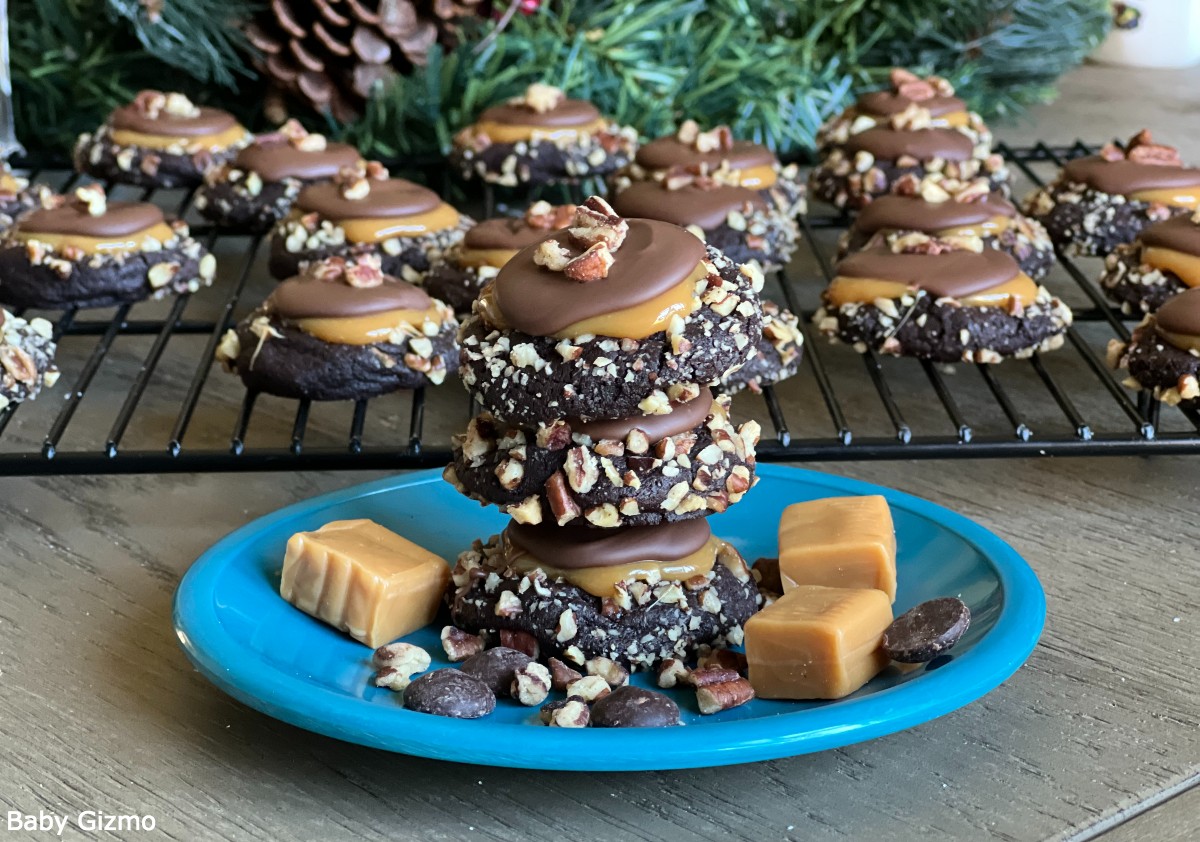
[175,465,1045,771]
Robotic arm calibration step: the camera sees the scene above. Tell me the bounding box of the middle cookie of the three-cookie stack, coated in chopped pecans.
[445,389,760,528]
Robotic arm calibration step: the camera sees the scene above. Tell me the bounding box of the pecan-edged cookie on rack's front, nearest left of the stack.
[216,254,457,401]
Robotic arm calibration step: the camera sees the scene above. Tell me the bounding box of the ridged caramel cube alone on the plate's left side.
[280,519,450,646]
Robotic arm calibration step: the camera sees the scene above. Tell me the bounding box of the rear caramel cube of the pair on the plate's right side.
[779,494,896,602]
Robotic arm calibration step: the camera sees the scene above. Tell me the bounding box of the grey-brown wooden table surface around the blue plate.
[0,67,1200,842]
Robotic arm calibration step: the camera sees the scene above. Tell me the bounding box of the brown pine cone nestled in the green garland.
[245,0,488,122]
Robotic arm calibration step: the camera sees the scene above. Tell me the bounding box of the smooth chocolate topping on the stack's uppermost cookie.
[494,219,704,336]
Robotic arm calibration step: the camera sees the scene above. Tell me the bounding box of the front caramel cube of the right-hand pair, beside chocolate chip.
[745,585,892,699]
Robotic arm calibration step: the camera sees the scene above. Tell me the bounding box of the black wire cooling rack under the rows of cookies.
[0,142,1200,475]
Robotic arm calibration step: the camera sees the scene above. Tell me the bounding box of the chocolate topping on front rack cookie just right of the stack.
[838,248,1021,299]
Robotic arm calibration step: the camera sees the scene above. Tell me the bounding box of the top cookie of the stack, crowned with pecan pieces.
[460,197,763,427]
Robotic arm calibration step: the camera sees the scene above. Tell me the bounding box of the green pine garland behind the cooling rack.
[10,0,1110,158]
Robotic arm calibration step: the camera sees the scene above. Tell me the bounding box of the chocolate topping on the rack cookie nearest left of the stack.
[266,276,431,319]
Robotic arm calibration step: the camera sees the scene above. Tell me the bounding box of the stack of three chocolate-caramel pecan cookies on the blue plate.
[445,197,762,668]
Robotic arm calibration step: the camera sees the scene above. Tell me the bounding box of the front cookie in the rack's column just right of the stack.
[812,234,1072,362]
